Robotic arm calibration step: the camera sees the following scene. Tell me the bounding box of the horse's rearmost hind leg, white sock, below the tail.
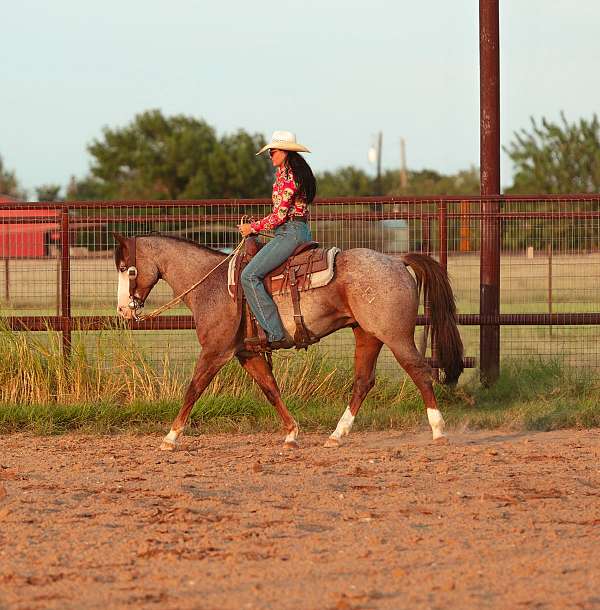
[387,336,445,441]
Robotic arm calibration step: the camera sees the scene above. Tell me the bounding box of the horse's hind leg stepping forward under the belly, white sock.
[325,326,383,447]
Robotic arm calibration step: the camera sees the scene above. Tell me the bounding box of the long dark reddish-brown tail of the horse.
[402,253,464,384]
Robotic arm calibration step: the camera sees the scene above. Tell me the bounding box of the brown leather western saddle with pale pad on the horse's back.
[228,237,339,353]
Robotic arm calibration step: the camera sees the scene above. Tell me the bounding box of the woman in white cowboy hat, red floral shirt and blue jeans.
[240,131,316,349]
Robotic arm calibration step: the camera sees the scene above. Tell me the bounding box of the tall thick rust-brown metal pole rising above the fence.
[479,0,500,385]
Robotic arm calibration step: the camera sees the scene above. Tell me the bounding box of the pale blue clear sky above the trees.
[0,0,600,198]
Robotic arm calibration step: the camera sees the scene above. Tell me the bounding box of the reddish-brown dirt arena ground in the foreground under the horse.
[0,430,600,610]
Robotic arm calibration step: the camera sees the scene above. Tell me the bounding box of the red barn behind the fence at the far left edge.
[0,195,60,258]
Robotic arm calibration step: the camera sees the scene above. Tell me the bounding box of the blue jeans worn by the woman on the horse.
[241,220,312,341]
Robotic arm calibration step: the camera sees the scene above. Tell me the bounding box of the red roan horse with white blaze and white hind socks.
[115,234,463,450]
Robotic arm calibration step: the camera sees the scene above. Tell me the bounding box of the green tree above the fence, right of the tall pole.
[504,112,600,194]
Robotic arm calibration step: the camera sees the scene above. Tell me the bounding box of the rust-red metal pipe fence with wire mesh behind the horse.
[0,195,600,374]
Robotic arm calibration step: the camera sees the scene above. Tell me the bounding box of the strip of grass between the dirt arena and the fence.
[0,318,600,434]
